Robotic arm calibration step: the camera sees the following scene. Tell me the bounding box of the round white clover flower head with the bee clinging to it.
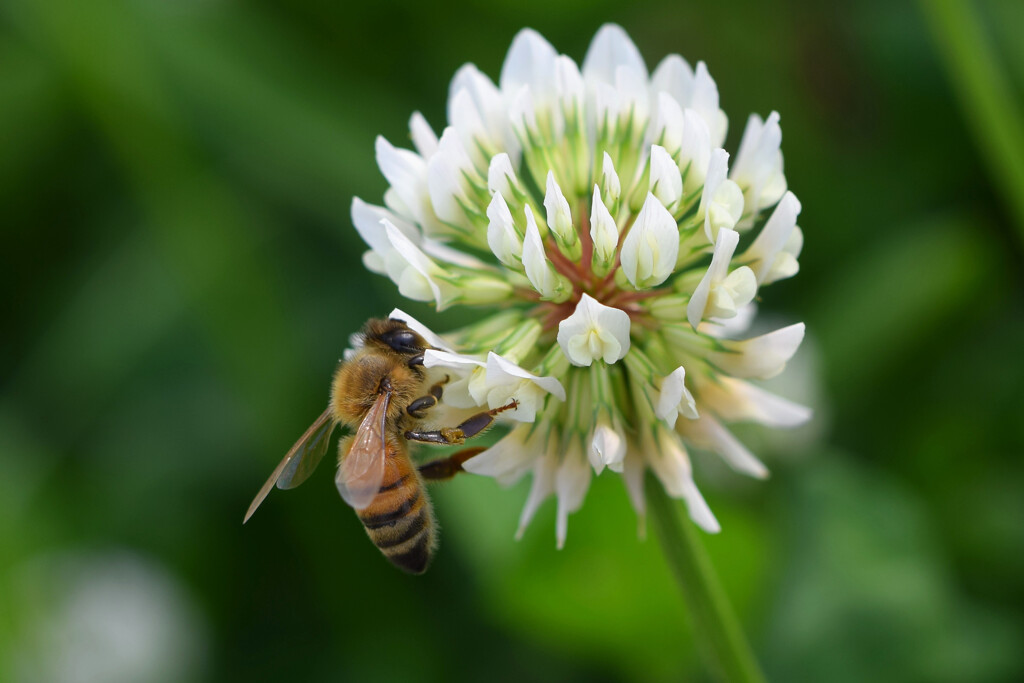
[352,25,810,547]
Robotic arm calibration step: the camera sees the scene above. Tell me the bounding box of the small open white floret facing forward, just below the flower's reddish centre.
[557,294,630,366]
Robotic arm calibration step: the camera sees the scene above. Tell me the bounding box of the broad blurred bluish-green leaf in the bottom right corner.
[767,454,1024,683]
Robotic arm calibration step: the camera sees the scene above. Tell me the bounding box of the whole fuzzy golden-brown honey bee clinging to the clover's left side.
[243,318,518,573]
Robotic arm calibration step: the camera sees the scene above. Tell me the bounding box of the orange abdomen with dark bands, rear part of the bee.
[356,438,435,573]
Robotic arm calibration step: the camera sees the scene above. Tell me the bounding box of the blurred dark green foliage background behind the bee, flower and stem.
[0,0,1024,682]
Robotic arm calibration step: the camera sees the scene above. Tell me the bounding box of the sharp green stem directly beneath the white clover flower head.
[646,473,764,683]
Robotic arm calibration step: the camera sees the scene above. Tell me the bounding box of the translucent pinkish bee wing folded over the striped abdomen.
[335,392,391,510]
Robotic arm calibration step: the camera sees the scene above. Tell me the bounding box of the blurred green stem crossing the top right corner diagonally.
[921,0,1024,245]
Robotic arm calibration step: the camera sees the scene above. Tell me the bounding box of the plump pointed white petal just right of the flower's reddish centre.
[620,194,679,289]
